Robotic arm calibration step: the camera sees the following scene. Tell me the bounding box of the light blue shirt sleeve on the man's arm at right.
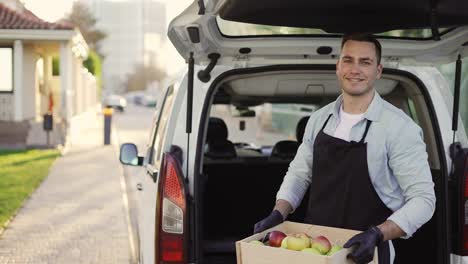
[387,123,436,238]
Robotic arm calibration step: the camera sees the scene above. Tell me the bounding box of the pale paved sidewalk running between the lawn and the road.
[0,111,132,264]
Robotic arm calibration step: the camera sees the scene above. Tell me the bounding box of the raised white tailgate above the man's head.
[168,0,468,64]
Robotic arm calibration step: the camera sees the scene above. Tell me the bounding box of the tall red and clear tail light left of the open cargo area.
[155,153,187,264]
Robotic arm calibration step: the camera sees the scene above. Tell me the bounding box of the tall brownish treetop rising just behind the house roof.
[65,2,107,52]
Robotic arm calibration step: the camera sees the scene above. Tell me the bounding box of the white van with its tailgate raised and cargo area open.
[120,0,468,264]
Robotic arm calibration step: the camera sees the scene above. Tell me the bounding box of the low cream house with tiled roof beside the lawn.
[0,0,96,148]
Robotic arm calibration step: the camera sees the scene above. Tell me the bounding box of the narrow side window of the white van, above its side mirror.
[150,85,174,167]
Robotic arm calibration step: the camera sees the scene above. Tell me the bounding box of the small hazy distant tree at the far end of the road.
[125,64,166,91]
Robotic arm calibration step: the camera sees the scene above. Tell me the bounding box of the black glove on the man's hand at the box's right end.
[343,226,383,264]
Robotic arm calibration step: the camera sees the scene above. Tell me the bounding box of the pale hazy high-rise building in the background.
[81,0,166,94]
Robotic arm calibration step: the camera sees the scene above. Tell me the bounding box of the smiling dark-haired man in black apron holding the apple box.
[254,34,435,264]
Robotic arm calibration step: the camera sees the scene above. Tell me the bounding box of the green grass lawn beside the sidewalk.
[0,149,60,227]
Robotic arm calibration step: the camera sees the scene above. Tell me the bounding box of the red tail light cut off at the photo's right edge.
[459,155,468,256]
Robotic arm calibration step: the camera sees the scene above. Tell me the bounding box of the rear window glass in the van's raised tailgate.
[216,16,450,39]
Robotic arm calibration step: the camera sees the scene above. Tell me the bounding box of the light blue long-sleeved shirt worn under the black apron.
[276,92,436,238]
